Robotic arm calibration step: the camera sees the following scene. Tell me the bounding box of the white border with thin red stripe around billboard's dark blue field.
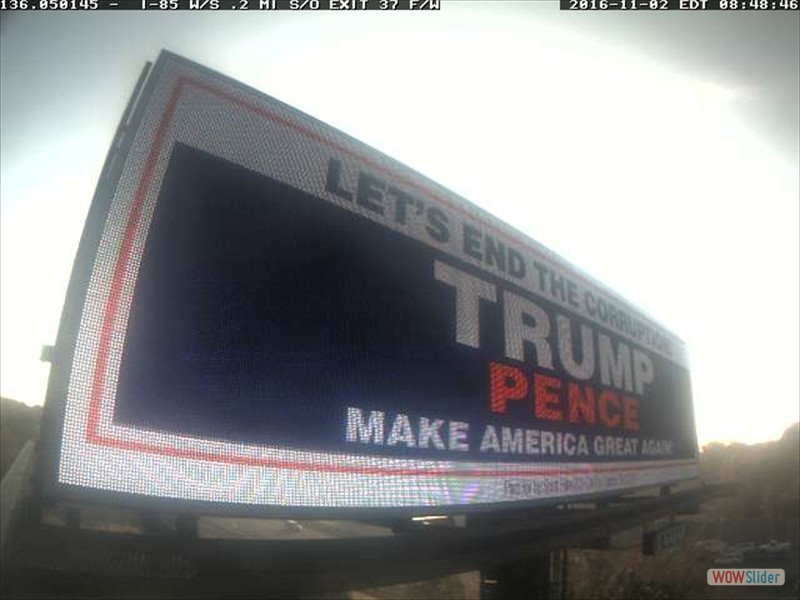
[57,55,697,508]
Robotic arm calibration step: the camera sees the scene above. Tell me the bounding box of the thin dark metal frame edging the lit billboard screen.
[39,52,696,518]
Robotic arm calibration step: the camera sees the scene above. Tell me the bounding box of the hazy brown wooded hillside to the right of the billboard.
[567,423,800,600]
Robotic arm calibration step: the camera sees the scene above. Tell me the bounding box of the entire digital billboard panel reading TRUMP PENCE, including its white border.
[43,53,697,512]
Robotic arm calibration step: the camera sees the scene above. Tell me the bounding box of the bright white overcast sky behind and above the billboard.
[0,2,800,444]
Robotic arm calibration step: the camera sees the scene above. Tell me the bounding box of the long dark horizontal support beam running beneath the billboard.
[4,485,736,597]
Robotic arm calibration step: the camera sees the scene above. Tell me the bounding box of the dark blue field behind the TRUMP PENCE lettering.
[115,144,695,462]
